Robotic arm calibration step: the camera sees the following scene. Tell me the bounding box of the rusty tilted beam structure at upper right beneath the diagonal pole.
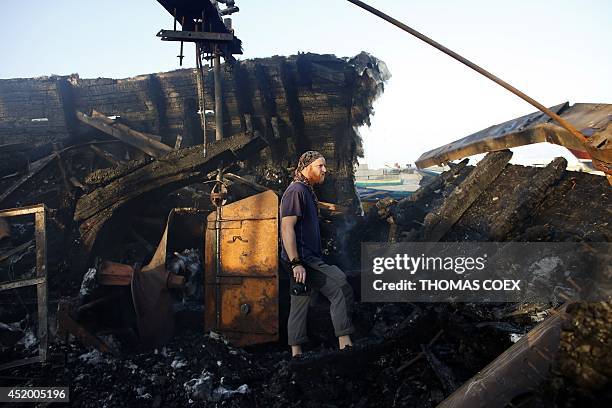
[416,102,612,172]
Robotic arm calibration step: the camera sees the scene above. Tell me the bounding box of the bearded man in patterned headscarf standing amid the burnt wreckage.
[280,151,354,357]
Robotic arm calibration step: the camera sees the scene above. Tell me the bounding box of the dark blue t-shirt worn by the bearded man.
[280,181,323,261]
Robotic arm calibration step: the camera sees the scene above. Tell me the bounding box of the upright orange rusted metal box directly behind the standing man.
[204,191,278,346]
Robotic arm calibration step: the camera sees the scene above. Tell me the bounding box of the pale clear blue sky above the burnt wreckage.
[0,0,612,166]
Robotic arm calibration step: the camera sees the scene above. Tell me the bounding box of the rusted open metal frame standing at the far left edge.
[0,204,48,370]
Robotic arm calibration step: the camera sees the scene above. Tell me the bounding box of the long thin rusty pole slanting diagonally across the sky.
[348,0,588,144]
